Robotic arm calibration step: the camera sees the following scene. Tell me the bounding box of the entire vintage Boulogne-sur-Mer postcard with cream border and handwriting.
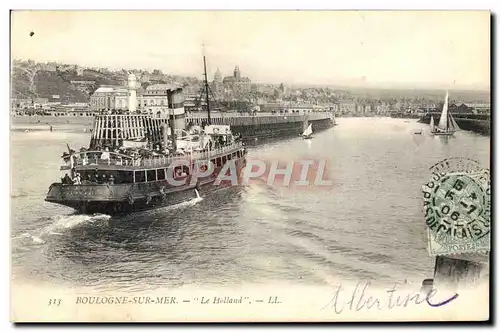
[9,10,492,323]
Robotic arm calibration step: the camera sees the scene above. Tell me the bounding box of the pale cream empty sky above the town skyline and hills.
[11,11,490,89]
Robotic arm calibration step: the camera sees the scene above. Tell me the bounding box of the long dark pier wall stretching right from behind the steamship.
[187,114,333,140]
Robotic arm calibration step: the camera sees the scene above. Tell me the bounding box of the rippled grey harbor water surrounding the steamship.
[11,118,490,291]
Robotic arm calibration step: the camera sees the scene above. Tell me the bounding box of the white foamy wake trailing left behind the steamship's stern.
[12,214,111,244]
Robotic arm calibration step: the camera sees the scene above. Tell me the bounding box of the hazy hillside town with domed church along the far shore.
[11,60,491,117]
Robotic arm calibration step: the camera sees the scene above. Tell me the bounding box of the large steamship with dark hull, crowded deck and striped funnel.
[45,58,247,215]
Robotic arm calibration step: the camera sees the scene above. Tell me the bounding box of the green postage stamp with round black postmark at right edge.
[422,158,491,256]
